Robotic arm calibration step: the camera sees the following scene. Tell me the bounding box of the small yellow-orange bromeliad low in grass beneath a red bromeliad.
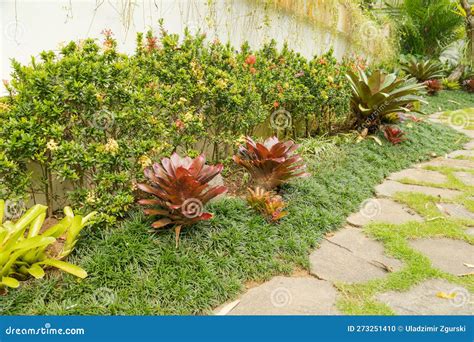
[247,187,288,222]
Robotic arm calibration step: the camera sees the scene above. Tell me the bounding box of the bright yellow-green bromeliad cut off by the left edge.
[0,200,95,292]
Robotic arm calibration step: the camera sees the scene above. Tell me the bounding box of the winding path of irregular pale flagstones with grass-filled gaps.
[215,115,474,315]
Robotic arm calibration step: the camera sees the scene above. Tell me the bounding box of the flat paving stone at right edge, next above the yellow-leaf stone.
[408,238,474,275]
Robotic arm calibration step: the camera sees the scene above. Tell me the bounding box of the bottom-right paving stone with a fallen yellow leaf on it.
[375,279,474,315]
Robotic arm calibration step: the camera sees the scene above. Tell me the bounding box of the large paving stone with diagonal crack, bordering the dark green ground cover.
[309,227,402,283]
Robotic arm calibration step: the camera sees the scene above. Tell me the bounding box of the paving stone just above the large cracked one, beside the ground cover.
[347,198,423,227]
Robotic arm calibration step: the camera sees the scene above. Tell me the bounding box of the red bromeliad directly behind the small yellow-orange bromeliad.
[233,137,309,190]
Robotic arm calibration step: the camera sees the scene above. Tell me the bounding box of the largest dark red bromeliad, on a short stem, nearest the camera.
[138,153,227,246]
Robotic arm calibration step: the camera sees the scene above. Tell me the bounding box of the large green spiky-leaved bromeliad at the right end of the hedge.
[346,69,425,133]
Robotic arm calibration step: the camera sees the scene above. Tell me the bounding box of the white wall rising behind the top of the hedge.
[0,0,356,92]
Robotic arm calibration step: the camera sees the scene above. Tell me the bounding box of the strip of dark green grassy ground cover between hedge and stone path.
[0,110,466,315]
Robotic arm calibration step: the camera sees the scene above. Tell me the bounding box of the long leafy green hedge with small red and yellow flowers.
[0,24,351,223]
